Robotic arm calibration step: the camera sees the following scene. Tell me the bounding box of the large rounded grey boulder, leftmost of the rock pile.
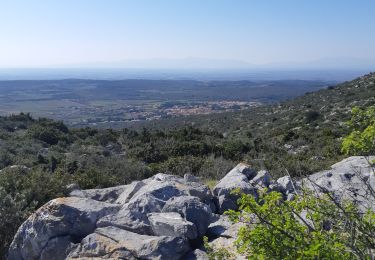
[8,197,119,259]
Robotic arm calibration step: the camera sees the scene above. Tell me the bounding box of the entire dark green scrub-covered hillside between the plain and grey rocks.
[0,73,375,255]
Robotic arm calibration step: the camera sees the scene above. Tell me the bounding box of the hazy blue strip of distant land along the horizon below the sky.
[0,68,371,83]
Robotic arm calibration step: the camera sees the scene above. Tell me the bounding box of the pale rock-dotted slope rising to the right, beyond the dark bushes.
[126,73,375,175]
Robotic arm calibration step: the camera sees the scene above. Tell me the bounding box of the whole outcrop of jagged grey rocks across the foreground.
[8,157,375,260]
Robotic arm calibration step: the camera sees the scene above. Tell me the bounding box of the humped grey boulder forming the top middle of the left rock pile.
[98,174,213,235]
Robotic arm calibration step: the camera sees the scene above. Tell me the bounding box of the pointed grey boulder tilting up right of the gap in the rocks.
[213,163,257,214]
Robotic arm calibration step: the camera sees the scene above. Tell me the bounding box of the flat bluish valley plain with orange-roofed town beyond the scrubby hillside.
[0,79,334,127]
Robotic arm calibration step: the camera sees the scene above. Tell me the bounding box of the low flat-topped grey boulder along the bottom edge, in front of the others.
[69,227,190,260]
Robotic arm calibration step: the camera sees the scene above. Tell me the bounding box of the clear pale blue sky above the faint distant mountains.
[0,0,375,68]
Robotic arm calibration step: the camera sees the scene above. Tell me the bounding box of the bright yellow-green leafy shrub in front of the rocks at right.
[214,93,375,259]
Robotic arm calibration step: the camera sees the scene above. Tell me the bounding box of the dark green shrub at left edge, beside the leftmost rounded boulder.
[0,169,67,256]
